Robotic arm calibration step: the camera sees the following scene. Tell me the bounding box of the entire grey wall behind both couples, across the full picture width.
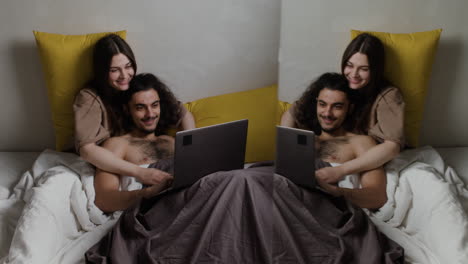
[4,0,468,151]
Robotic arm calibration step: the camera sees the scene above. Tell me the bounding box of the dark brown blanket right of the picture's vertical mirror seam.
[272,175,404,264]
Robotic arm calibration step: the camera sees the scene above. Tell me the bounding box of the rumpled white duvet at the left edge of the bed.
[0,150,138,263]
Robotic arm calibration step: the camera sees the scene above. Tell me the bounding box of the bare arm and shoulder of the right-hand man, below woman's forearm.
[317,136,387,209]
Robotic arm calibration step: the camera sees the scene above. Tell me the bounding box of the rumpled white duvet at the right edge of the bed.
[370,147,468,264]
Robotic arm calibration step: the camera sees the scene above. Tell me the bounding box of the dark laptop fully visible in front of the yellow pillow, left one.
[170,119,248,189]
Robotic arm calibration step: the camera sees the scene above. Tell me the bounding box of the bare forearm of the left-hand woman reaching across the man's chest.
[80,143,169,185]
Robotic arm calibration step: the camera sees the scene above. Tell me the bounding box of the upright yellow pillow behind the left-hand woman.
[33,31,126,151]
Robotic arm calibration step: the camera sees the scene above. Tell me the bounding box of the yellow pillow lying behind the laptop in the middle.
[185,85,278,162]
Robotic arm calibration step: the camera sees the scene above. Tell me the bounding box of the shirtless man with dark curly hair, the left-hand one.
[94,74,183,212]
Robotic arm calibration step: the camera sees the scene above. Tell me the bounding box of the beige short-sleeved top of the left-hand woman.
[73,88,188,153]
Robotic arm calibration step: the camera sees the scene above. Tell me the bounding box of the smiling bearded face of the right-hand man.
[317,88,349,133]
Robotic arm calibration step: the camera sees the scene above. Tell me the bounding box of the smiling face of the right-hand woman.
[343,52,370,89]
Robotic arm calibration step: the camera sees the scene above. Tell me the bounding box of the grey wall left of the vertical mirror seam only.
[0,0,281,151]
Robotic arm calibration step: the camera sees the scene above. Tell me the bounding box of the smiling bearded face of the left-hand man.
[128,89,161,134]
